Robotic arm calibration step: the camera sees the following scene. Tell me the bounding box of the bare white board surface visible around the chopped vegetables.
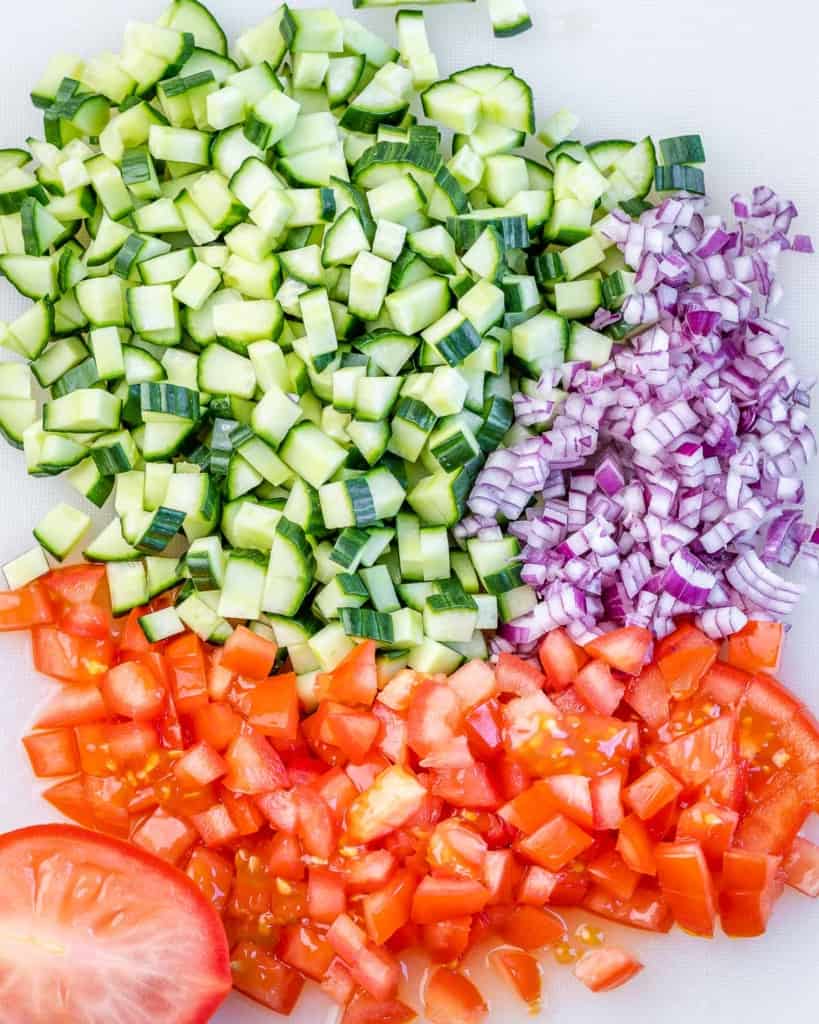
[0,0,819,1024]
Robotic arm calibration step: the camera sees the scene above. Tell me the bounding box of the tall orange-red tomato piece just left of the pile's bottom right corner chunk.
[654,843,717,938]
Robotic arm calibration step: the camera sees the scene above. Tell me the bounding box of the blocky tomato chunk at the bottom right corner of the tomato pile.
[720,850,781,938]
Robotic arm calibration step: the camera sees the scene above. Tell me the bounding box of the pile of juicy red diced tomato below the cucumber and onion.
[0,565,819,1024]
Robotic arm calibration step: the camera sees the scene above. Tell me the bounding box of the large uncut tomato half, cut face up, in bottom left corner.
[0,825,230,1024]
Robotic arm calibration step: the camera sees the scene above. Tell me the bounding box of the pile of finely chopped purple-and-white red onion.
[458,188,819,651]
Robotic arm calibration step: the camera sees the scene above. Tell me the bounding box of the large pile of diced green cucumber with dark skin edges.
[0,0,679,687]
